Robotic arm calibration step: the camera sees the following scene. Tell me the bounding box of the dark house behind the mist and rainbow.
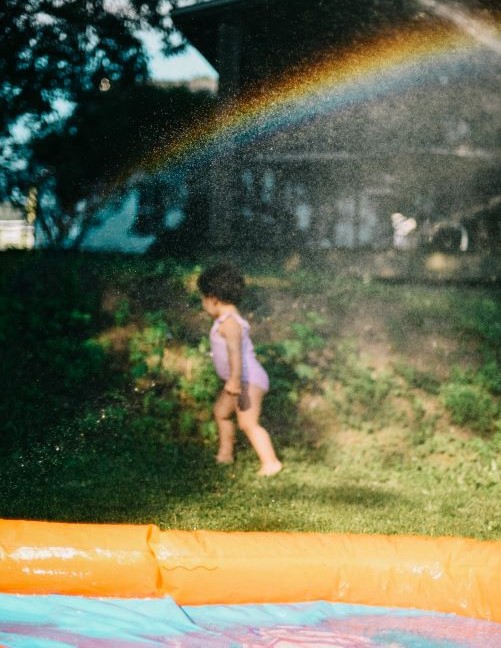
[166,0,501,249]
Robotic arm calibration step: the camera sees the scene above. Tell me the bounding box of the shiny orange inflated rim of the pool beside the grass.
[0,520,501,622]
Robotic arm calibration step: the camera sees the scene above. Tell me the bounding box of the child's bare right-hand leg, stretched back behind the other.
[237,385,282,477]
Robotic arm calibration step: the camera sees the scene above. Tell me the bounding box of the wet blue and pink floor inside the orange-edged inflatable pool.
[0,594,501,648]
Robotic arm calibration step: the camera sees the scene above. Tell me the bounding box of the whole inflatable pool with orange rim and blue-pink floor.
[0,520,501,648]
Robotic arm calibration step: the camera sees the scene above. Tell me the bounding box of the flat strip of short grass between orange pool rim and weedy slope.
[1,441,500,538]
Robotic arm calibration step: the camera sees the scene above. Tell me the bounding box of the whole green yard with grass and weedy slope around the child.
[0,253,501,539]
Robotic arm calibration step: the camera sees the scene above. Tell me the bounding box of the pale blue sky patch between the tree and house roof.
[141,32,217,81]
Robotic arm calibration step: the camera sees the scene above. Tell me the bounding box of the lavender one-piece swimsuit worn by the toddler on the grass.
[210,313,269,391]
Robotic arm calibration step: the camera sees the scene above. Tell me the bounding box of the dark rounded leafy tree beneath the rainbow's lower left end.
[30,84,214,245]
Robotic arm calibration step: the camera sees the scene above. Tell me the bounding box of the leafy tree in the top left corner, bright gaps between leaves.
[0,0,210,238]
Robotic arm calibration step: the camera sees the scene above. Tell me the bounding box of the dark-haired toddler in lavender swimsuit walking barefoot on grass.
[197,263,282,477]
